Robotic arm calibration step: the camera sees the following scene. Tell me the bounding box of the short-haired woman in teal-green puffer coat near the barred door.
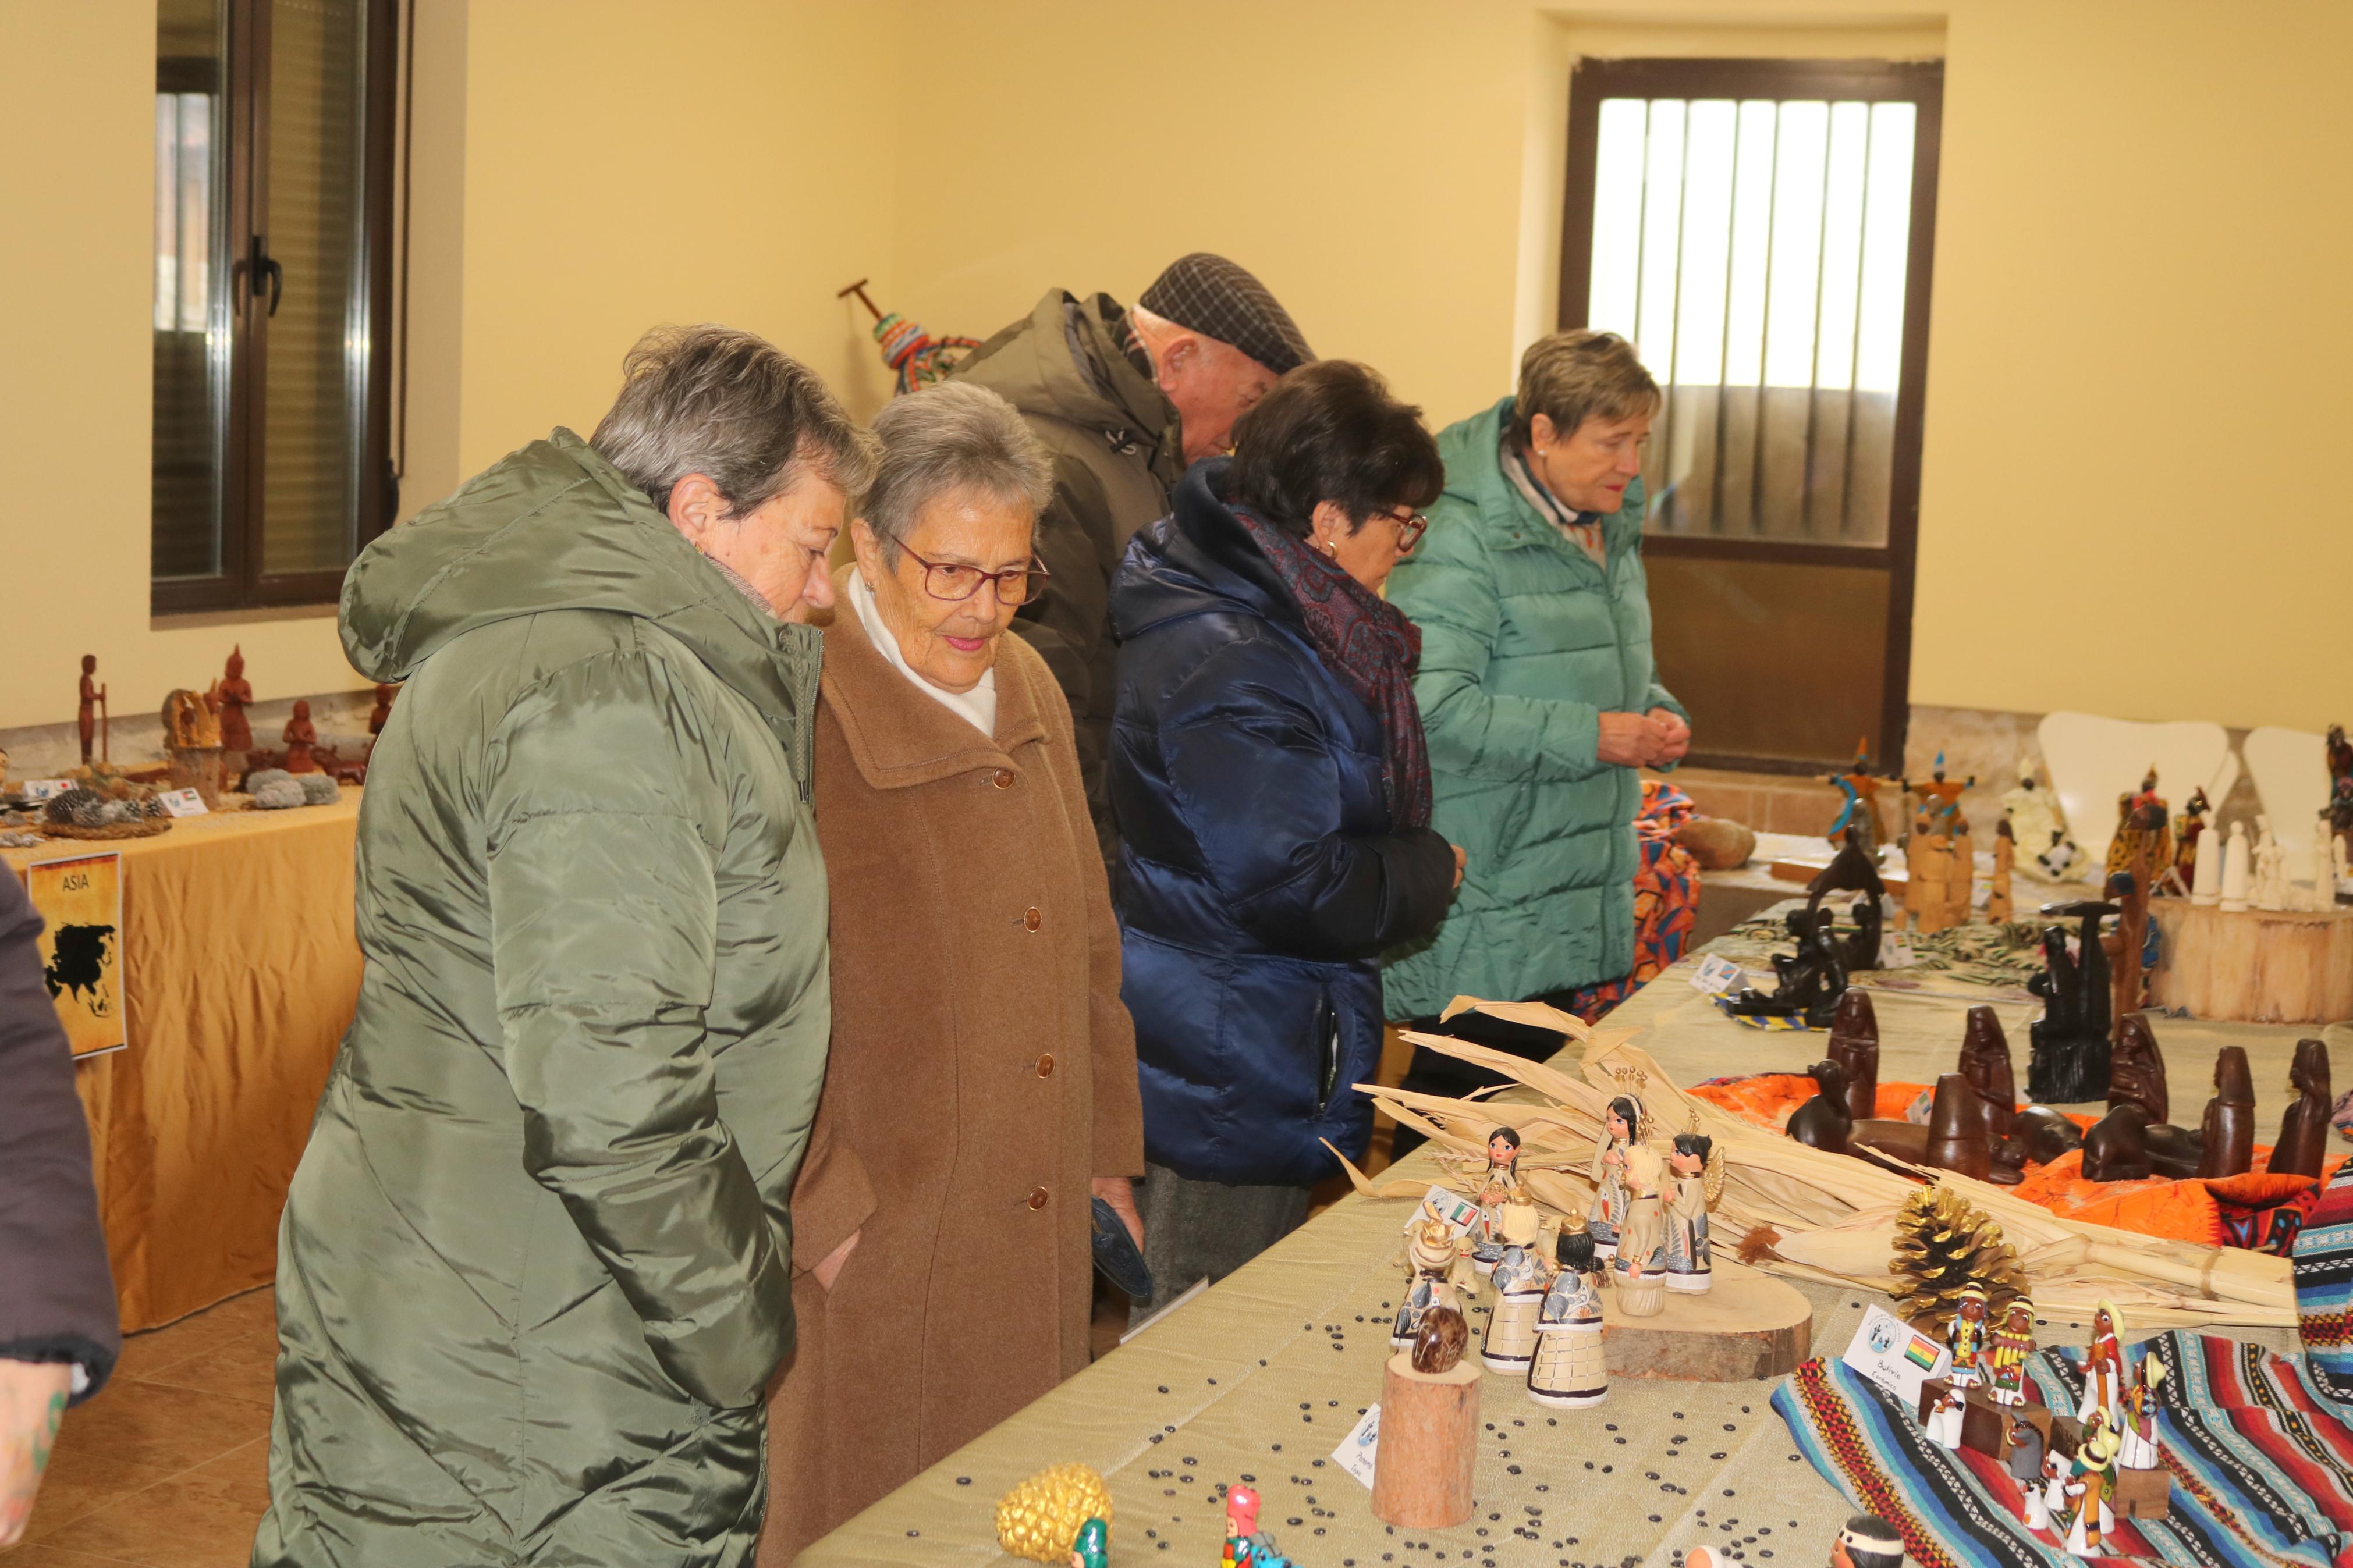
[1381,332,1692,1093]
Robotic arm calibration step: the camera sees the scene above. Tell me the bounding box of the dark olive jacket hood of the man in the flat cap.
[955,289,1184,484]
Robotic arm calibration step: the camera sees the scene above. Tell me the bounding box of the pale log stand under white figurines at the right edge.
[2148,898,2353,1023]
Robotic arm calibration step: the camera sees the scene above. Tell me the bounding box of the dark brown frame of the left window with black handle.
[148,0,400,616]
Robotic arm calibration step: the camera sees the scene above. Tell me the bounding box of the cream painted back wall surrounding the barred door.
[896,0,2353,729]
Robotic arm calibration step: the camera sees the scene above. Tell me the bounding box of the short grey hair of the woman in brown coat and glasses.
[859,381,1054,567]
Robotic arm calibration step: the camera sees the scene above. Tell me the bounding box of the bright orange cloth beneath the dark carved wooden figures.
[1692,1072,2337,1246]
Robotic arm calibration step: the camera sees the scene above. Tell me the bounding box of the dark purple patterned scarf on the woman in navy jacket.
[1233,506,1431,832]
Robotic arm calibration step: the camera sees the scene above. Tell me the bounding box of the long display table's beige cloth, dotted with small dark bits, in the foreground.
[800,957,2348,1568]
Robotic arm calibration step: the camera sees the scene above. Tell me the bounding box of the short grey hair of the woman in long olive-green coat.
[588,322,875,517]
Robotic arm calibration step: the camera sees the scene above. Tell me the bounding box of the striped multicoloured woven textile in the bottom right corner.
[1772,1331,2353,1568]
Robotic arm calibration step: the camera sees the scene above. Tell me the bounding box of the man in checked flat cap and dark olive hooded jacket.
[955,251,1315,867]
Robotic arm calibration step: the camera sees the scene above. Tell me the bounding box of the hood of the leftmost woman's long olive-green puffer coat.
[341,430,819,757]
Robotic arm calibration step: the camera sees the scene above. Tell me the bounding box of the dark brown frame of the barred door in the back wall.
[1560,59,1944,773]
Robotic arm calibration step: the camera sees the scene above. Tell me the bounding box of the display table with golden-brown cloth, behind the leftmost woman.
[0,788,360,1331]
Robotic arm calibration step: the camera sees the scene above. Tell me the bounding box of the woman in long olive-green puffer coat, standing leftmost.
[252,327,871,1568]
